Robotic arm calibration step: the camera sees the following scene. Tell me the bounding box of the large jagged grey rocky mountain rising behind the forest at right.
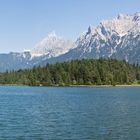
[56,13,140,63]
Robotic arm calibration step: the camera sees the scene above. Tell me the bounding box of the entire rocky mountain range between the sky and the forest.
[0,12,140,71]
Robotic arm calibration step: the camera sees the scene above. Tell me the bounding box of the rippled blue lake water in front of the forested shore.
[0,86,140,140]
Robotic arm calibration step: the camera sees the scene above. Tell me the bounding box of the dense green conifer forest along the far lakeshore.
[0,59,140,86]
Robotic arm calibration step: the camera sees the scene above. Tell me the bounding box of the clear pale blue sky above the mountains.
[0,0,140,53]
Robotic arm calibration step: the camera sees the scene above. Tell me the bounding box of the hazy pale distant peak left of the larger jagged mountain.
[31,32,75,58]
